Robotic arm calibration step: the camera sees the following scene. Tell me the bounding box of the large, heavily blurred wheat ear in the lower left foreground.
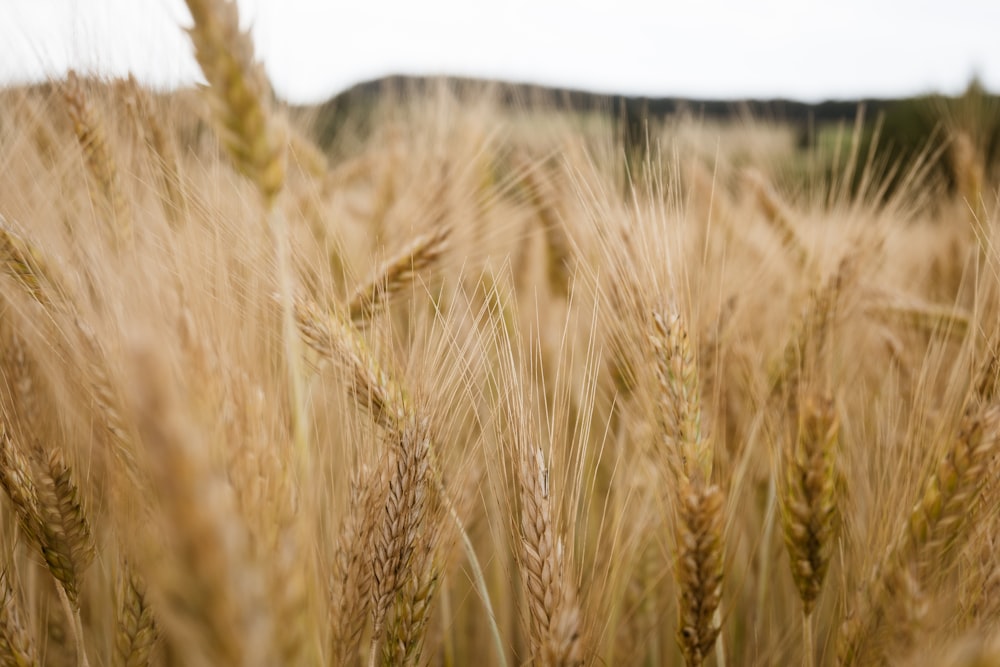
[132,351,274,665]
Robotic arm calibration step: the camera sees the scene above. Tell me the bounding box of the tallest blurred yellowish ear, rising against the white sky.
[187,0,285,208]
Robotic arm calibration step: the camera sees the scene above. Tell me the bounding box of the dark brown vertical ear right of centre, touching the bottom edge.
[677,480,725,666]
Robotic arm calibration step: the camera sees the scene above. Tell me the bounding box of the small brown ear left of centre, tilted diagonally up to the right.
[348,226,449,323]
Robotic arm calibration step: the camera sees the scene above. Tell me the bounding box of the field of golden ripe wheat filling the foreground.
[0,0,1000,667]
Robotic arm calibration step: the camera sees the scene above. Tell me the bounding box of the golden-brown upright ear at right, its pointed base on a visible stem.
[782,397,839,616]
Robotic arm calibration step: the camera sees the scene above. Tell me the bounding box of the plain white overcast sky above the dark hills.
[0,0,1000,102]
